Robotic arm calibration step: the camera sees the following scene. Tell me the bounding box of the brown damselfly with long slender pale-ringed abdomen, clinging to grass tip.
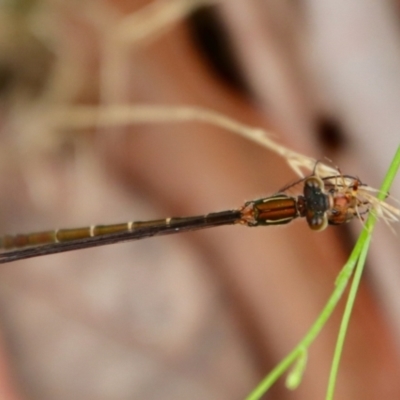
[0,170,369,263]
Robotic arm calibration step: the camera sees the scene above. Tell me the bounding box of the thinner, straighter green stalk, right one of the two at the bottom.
[326,147,400,400]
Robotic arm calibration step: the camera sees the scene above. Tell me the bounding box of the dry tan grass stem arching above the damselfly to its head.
[49,105,400,227]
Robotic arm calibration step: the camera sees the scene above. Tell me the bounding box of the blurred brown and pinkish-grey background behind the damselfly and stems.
[0,0,400,400]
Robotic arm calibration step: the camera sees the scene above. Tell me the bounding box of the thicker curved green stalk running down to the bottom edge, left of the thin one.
[246,147,400,400]
